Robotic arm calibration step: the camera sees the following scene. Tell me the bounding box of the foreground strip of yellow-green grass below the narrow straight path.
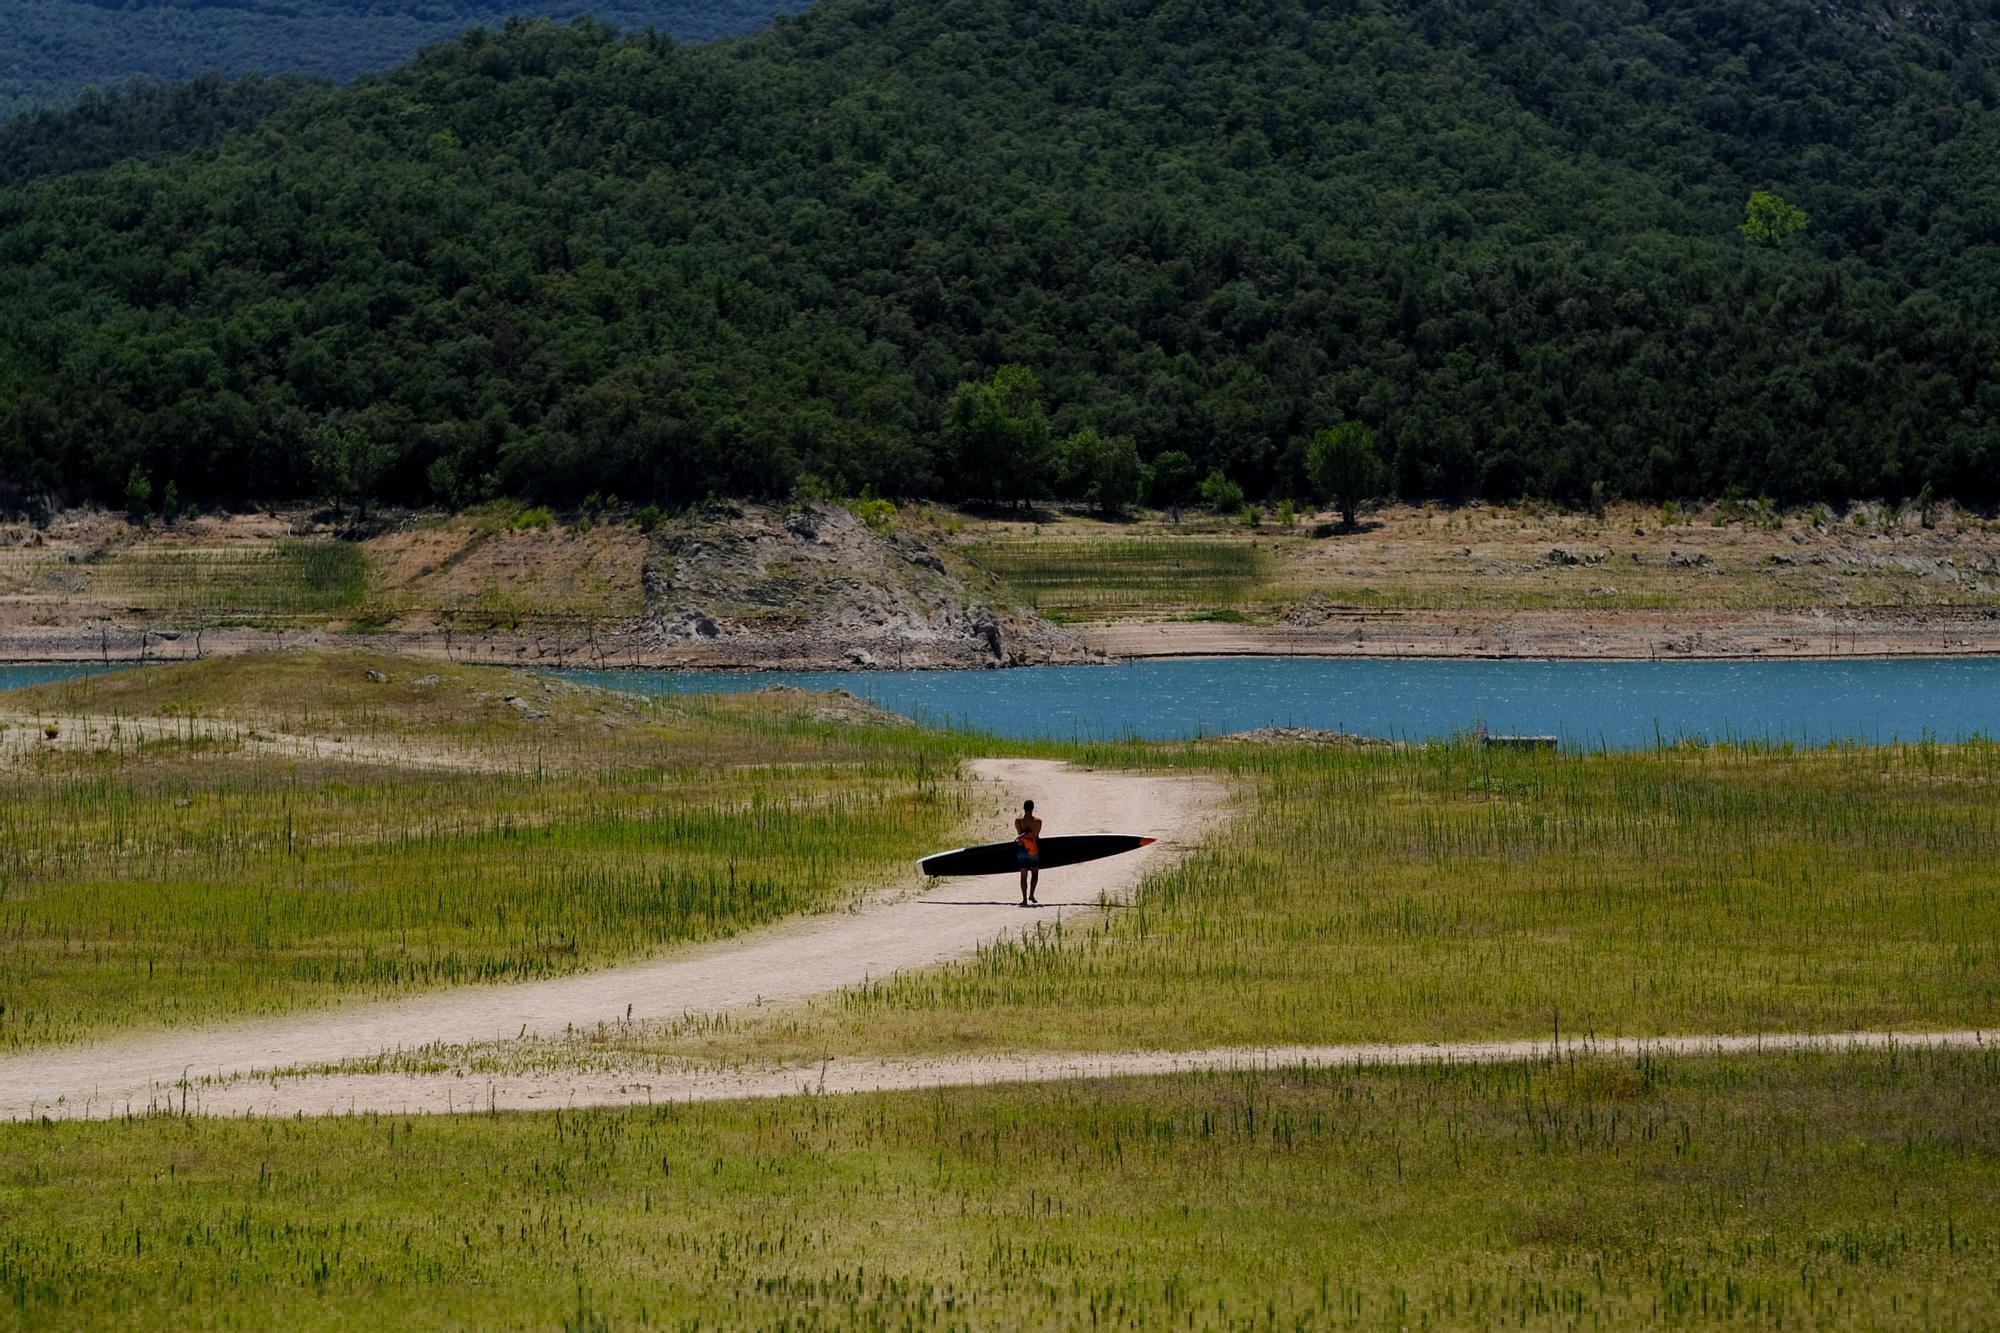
[0,1051,2000,1329]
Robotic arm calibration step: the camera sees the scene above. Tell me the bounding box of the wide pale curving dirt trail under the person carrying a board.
[0,759,1224,1119]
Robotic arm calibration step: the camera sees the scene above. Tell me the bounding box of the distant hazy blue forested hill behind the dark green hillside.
[0,0,798,120]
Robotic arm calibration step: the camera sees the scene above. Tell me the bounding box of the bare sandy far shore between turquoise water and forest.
[0,504,2000,669]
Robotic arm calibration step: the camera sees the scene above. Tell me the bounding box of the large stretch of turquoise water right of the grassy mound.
[566,658,2000,749]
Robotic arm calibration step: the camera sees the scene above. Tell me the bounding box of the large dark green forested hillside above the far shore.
[0,0,2000,504]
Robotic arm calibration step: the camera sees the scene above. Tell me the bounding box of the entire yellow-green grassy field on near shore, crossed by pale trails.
[0,652,2000,1329]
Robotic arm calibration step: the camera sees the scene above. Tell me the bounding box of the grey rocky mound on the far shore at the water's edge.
[644,504,1100,669]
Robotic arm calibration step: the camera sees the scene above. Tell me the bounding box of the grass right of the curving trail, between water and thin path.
[634,743,2000,1059]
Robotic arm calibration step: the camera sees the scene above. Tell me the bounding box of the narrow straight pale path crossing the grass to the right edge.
[54,1031,2000,1119]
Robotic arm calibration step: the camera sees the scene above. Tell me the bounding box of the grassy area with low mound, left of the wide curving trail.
[0,652,964,1049]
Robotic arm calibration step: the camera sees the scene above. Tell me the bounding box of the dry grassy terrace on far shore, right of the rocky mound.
[960,502,2000,624]
